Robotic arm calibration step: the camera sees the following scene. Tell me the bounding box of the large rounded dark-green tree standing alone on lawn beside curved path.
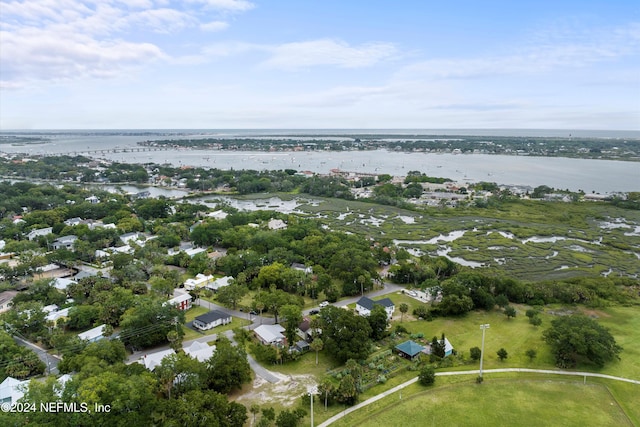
[542,315,622,368]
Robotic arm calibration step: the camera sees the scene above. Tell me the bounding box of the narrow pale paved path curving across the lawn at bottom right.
[318,368,640,427]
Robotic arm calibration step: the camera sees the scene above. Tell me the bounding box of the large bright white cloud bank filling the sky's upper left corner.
[0,0,253,88]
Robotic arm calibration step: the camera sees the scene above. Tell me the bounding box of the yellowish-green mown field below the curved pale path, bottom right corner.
[334,380,633,427]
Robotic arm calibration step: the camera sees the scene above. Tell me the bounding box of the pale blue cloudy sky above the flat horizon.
[0,0,640,130]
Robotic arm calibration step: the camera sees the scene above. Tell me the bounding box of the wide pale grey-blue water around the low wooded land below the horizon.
[0,129,640,193]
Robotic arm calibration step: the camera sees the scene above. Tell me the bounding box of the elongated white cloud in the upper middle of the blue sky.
[262,39,397,70]
